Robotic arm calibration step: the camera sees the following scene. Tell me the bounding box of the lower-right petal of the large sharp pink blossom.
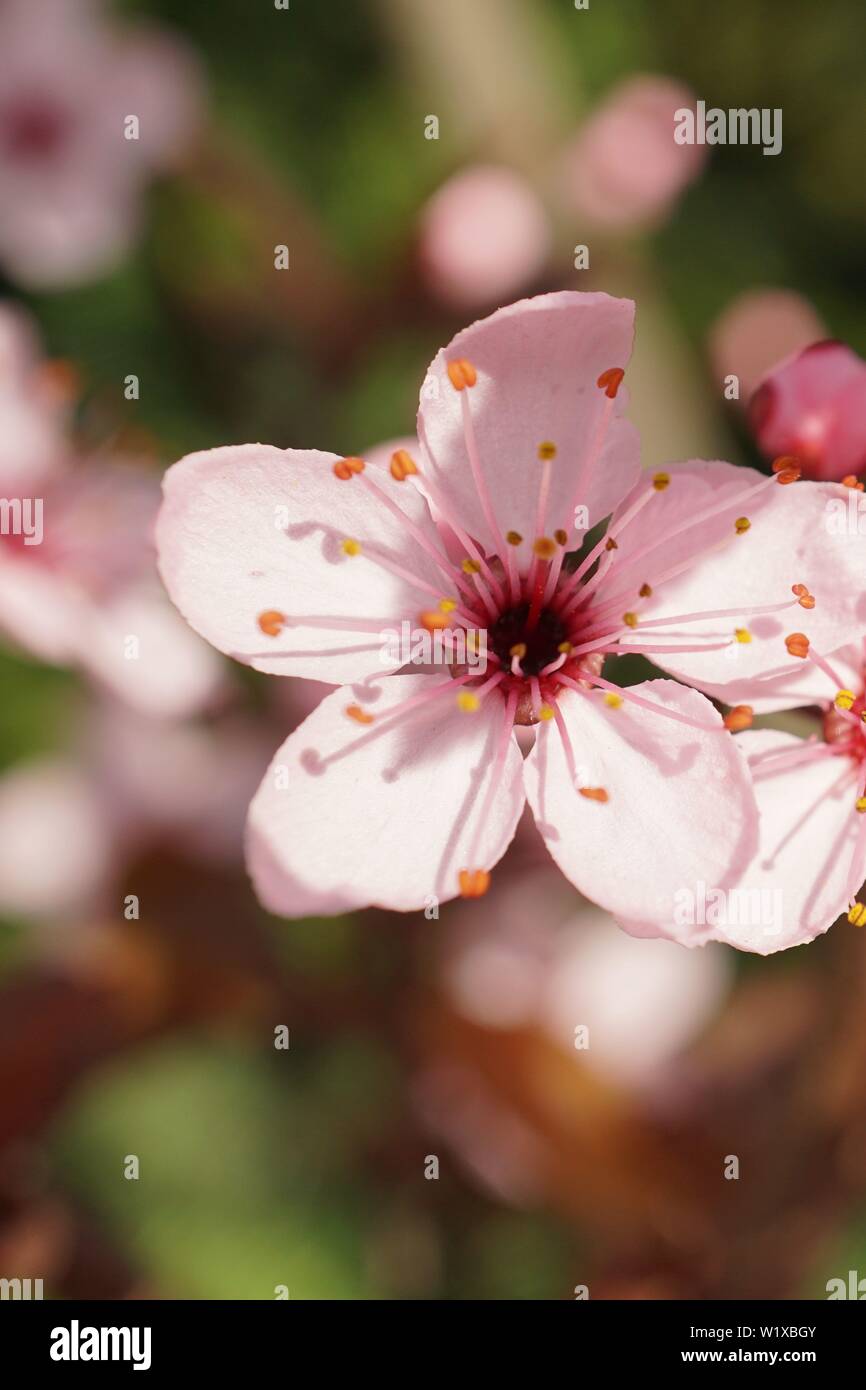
[525,680,758,938]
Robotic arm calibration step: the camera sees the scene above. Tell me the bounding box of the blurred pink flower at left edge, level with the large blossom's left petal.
[0,307,222,717]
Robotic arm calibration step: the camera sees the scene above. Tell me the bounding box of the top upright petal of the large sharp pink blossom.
[418,291,639,559]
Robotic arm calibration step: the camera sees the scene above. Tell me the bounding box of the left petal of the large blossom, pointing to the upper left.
[157,445,446,684]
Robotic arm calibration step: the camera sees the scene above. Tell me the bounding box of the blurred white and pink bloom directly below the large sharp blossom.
[442,865,730,1087]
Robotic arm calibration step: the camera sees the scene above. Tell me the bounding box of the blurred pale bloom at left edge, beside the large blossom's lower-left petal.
[0,701,270,922]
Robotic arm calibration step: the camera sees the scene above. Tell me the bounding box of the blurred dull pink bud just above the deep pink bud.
[709,289,827,405]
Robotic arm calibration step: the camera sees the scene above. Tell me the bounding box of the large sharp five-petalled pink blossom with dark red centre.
[157,292,866,934]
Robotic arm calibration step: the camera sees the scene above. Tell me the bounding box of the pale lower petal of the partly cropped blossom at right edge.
[695,730,866,955]
